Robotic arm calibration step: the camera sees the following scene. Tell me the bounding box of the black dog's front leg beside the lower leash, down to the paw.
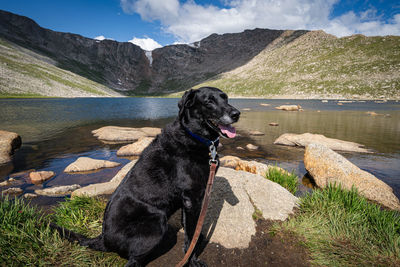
[182,195,207,267]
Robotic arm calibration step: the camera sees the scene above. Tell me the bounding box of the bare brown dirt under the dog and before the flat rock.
[142,214,310,267]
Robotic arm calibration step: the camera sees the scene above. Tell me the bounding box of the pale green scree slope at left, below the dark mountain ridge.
[0,38,120,97]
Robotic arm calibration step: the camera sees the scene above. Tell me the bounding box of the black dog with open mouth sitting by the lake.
[53,87,240,266]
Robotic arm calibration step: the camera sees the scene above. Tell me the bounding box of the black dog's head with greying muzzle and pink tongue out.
[178,87,240,138]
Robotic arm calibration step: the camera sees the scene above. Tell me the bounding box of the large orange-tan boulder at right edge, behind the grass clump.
[304,144,400,210]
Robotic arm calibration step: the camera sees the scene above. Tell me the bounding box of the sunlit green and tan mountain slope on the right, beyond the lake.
[196,31,400,99]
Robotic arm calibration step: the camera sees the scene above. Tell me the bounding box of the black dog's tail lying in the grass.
[50,223,107,251]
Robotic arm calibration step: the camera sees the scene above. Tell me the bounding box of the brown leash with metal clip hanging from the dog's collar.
[175,141,218,267]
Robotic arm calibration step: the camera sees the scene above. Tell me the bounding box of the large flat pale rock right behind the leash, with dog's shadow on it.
[202,167,297,248]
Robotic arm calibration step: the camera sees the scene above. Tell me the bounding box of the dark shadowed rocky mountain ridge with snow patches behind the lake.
[0,11,307,94]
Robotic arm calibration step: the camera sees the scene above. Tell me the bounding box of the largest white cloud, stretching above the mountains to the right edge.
[121,0,400,43]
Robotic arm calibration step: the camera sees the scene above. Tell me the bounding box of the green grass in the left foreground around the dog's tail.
[0,198,126,266]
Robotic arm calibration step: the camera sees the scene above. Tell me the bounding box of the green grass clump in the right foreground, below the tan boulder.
[276,185,400,266]
